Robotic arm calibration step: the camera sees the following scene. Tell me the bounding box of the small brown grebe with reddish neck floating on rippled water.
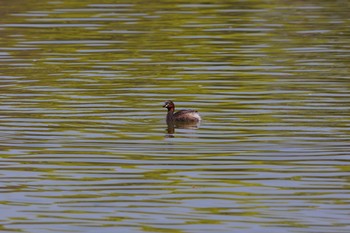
[163,100,202,123]
